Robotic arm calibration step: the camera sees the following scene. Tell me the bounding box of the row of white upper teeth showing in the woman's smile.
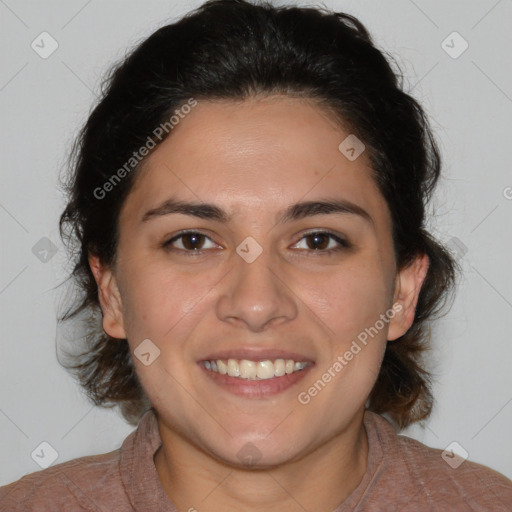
[203,359,308,380]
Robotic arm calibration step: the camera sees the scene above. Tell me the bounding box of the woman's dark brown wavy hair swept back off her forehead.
[59,0,457,428]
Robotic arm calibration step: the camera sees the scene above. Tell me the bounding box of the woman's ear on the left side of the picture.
[89,255,126,339]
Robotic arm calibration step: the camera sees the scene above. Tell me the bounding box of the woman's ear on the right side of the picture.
[388,254,429,341]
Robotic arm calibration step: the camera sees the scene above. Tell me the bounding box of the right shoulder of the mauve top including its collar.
[362,413,512,512]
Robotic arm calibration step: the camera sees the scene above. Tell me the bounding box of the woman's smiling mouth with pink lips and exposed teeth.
[198,351,315,398]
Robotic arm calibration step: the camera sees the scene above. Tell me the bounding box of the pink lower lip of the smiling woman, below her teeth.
[199,364,314,398]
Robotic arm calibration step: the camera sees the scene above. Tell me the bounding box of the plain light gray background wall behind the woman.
[0,0,512,484]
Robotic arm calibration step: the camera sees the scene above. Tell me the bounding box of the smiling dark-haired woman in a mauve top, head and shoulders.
[0,0,512,512]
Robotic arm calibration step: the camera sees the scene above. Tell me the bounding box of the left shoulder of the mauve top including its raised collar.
[0,410,160,512]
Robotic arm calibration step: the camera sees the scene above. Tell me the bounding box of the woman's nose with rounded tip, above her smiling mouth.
[216,250,298,332]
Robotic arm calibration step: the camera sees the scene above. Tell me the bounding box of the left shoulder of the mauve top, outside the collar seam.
[0,450,122,512]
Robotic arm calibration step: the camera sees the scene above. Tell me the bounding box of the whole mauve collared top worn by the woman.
[0,411,512,512]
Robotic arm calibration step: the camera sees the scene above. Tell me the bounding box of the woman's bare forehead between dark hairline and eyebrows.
[124,96,386,226]
